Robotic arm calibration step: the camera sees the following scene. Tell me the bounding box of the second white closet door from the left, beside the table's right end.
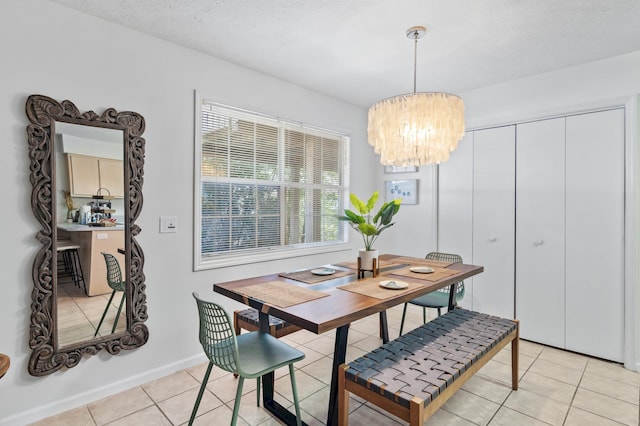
[472,126,515,318]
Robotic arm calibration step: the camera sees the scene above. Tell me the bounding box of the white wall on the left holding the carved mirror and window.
[0,0,377,425]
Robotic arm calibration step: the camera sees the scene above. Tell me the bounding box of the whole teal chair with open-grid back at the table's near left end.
[189,293,304,426]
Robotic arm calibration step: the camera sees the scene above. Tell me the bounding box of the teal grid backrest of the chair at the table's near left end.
[193,292,239,373]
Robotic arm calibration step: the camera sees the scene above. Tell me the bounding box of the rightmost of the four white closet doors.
[566,109,624,361]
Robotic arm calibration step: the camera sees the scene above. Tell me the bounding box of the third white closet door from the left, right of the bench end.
[516,117,565,348]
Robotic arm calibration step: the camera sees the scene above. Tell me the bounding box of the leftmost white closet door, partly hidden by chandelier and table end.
[438,132,473,309]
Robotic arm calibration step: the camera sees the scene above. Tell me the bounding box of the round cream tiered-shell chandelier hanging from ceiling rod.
[367,27,464,167]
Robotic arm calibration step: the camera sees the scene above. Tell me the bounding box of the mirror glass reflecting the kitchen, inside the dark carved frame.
[54,122,126,347]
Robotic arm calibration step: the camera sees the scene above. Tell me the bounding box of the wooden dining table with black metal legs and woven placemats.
[213,254,483,425]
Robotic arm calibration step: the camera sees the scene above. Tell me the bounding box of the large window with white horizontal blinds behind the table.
[195,99,349,270]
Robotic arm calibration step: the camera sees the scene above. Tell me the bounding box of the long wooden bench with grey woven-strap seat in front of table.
[338,308,519,426]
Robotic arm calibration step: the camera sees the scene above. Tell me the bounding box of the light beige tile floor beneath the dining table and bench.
[35,306,640,426]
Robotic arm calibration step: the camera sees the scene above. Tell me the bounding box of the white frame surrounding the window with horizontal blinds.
[193,92,350,271]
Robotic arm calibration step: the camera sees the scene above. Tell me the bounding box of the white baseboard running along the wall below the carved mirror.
[0,353,207,426]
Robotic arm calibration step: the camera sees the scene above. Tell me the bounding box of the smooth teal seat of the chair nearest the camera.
[237,332,304,378]
